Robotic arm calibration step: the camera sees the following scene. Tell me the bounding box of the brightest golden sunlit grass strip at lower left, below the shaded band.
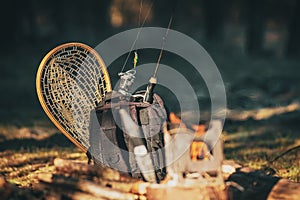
[0,147,86,188]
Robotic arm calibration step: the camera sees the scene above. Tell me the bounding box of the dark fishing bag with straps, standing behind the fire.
[89,92,167,182]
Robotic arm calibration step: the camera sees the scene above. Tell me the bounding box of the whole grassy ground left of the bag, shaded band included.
[0,123,86,188]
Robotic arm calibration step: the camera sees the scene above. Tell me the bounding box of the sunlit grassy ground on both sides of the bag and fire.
[0,108,300,191]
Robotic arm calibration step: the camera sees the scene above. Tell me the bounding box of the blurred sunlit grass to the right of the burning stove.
[224,112,300,182]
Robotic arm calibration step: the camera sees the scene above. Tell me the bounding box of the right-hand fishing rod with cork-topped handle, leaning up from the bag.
[143,15,173,104]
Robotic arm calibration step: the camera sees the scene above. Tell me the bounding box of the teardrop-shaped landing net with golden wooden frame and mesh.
[36,42,112,152]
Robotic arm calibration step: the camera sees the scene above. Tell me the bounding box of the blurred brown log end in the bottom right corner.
[268,179,300,200]
